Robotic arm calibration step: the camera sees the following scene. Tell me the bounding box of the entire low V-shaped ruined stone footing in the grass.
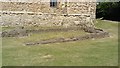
[1,27,109,46]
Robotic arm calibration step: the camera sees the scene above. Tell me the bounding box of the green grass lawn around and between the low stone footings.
[2,20,118,66]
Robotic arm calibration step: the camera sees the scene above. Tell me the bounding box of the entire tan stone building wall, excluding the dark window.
[0,1,96,27]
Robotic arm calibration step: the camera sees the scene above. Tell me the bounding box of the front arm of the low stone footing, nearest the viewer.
[25,31,109,46]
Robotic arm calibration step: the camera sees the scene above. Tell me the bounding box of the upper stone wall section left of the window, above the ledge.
[1,2,62,14]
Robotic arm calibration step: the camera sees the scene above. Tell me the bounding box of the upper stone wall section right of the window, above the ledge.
[67,2,96,15]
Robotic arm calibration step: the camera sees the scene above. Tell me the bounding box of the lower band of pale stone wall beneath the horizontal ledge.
[1,12,93,27]
